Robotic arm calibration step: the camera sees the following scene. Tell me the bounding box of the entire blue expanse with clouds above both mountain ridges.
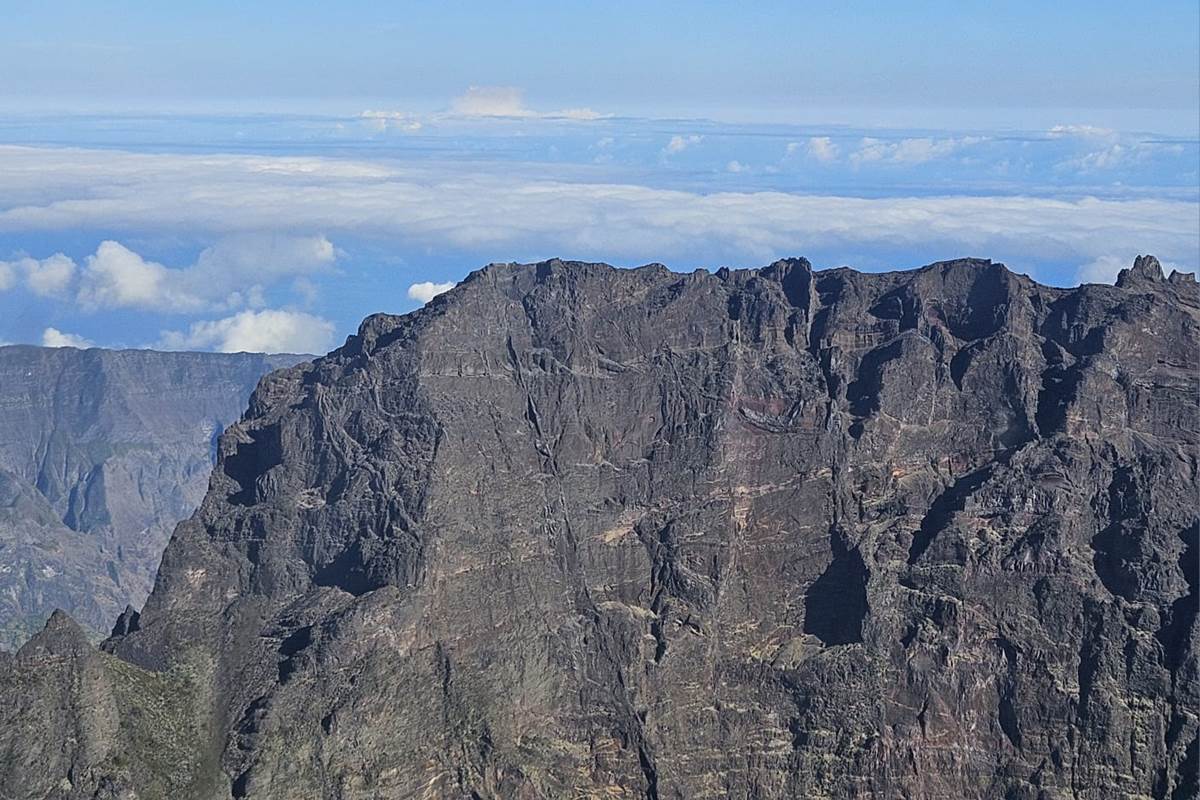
[0,2,1200,350]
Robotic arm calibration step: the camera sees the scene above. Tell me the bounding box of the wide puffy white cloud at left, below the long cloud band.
[73,234,337,312]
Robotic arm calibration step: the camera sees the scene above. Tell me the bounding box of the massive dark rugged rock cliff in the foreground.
[0,257,1200,800]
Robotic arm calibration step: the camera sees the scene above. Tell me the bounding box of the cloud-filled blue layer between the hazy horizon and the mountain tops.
[0,122,1200,351]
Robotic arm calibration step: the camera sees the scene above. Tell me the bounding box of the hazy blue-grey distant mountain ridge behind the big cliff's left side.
[0,345,301,649]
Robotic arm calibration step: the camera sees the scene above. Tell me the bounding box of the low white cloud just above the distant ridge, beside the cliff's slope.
[158,308,334,354]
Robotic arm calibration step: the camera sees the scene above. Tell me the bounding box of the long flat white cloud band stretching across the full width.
[0,146,1200,284]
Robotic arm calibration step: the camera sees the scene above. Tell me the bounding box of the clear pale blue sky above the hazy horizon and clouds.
[0,0,1200,126]
